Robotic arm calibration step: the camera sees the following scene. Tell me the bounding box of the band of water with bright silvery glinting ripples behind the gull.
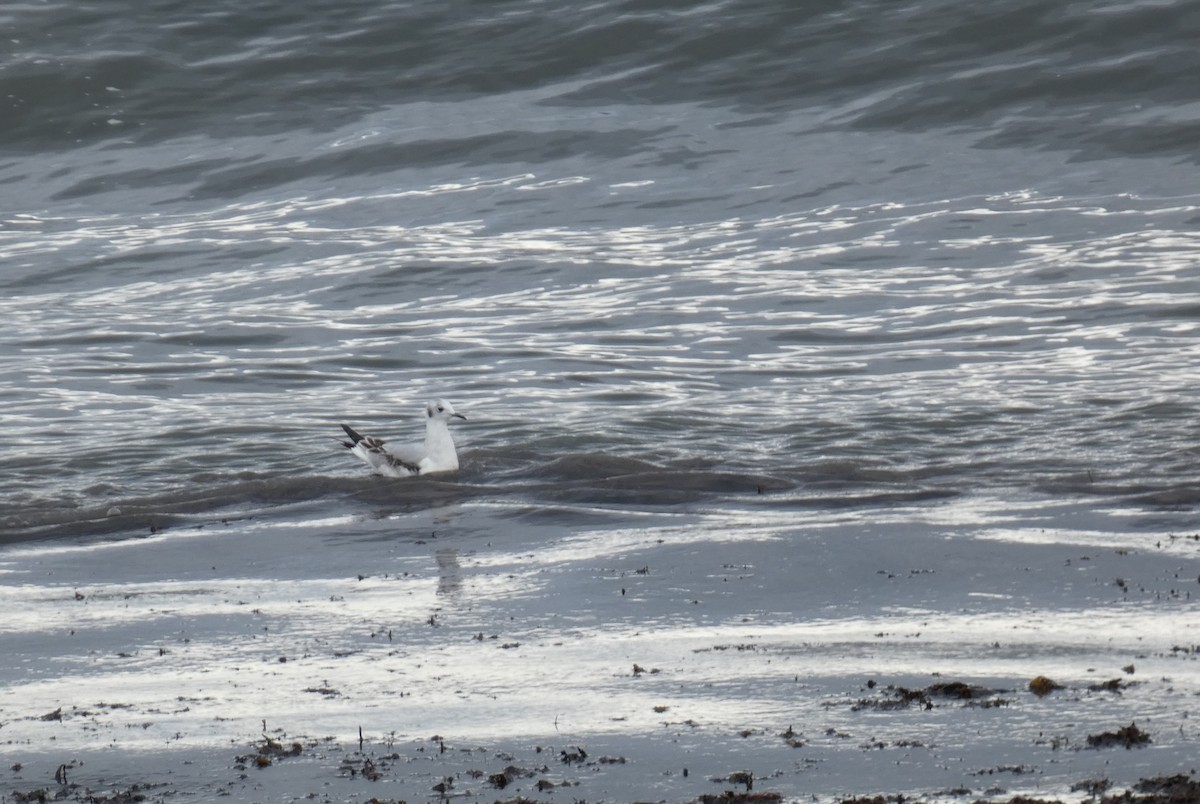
[0,189,1200,528]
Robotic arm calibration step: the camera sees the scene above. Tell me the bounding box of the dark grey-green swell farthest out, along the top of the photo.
[0,0,1200,160]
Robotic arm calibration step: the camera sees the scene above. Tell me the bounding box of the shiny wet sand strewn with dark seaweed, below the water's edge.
[0,487,1200,802]
